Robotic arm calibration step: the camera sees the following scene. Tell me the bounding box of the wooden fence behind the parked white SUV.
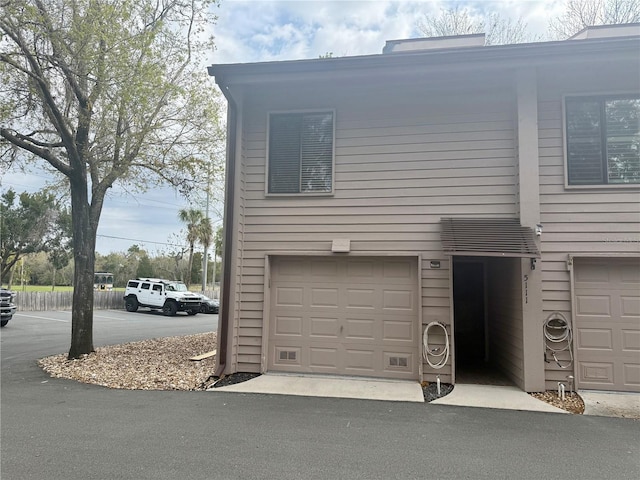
[14,290,215,312]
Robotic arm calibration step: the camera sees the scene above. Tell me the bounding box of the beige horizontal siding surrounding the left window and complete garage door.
[236,74,516,381]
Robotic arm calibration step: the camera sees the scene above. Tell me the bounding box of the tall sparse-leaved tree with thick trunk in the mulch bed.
[0,0,221,358]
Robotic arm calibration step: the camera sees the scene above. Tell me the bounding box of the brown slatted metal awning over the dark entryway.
[440,218,540,258]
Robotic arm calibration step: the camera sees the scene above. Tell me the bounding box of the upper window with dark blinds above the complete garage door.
[266,111,334,195]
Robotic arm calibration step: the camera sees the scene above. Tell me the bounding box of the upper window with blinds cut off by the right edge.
[565,95,640,186]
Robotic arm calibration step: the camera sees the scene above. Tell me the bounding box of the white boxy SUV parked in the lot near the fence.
[124,278,202,316]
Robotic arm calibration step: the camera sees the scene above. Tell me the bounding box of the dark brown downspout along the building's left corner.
[208,72,238,377]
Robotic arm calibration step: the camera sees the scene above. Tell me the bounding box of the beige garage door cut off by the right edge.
[575,260,640,392]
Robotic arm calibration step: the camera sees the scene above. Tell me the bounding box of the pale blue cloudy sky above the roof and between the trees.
[0,0,565,254]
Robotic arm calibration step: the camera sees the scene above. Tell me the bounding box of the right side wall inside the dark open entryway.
[487,258,524,388]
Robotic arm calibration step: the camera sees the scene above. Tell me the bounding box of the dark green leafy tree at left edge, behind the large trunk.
[0,189,60,283]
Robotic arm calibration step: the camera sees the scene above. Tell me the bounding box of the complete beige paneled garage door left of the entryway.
[268,257,419,379]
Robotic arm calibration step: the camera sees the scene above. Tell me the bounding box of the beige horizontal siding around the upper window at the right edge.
[538,60,640,388]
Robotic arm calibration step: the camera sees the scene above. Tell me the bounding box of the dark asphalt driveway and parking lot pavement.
[0,311,640,480]
